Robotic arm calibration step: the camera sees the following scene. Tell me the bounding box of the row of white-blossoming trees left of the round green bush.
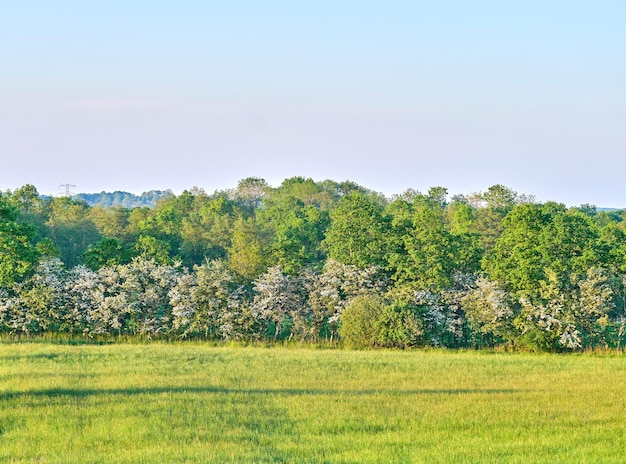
[0,258,388,340]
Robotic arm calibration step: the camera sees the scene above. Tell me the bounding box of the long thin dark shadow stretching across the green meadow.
[0,387,526,401]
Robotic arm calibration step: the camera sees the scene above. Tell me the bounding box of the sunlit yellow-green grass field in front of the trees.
[0,342,626,463]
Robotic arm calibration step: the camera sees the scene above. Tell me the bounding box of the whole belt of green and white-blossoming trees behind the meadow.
[0,177,626,351]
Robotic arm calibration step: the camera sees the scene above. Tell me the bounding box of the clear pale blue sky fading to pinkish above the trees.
[0,0,626,208]
